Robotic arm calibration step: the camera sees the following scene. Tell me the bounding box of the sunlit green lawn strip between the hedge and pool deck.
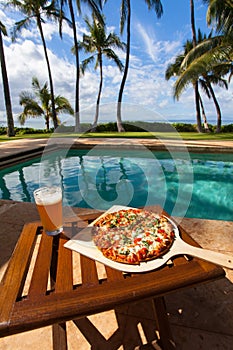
[0,132,233,142]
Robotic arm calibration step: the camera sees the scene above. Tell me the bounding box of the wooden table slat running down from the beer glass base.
[55,235,73,293]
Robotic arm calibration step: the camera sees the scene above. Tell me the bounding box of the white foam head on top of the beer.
[34,187,62,205]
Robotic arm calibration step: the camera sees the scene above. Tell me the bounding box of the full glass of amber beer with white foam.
[33,187,63,236]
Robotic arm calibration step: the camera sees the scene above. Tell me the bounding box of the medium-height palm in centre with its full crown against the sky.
[80,14,125,131]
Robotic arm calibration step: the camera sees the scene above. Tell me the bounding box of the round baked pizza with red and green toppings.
[92,208,175,264]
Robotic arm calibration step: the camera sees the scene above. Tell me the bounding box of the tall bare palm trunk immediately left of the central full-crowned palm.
[69,0,81,132]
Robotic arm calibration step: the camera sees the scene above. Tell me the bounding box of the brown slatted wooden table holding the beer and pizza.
[0,206,224,349]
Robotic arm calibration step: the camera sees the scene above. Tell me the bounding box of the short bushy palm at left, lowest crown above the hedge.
[19,77,74,131]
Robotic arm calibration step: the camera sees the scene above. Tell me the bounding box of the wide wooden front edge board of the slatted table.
[8,263,224,332]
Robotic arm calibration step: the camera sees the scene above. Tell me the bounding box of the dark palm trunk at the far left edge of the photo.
[0,21,15,136]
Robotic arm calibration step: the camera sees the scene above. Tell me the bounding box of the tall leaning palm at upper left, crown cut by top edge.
[9,0,65,129]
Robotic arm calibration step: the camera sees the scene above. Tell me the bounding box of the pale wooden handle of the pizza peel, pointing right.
[173,235,233,269]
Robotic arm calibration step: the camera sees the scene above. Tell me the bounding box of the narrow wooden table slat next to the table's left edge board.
[28,232,53,298]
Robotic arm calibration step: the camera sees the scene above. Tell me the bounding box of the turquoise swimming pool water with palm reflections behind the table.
[0,150,233,221]
